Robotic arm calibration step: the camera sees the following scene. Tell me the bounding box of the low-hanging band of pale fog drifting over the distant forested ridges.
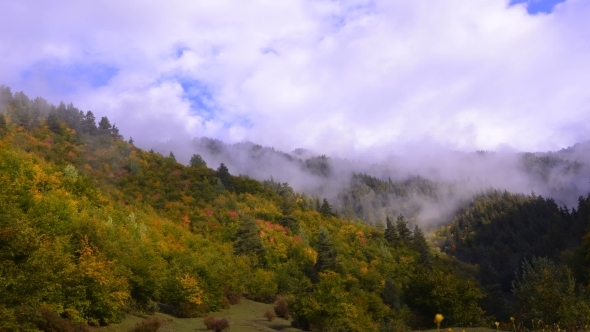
[153,138,590,226]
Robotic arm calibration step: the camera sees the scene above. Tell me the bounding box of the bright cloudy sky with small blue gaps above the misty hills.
[0,0,590,155]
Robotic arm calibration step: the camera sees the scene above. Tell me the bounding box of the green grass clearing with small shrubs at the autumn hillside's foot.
[91,299,301,332]
